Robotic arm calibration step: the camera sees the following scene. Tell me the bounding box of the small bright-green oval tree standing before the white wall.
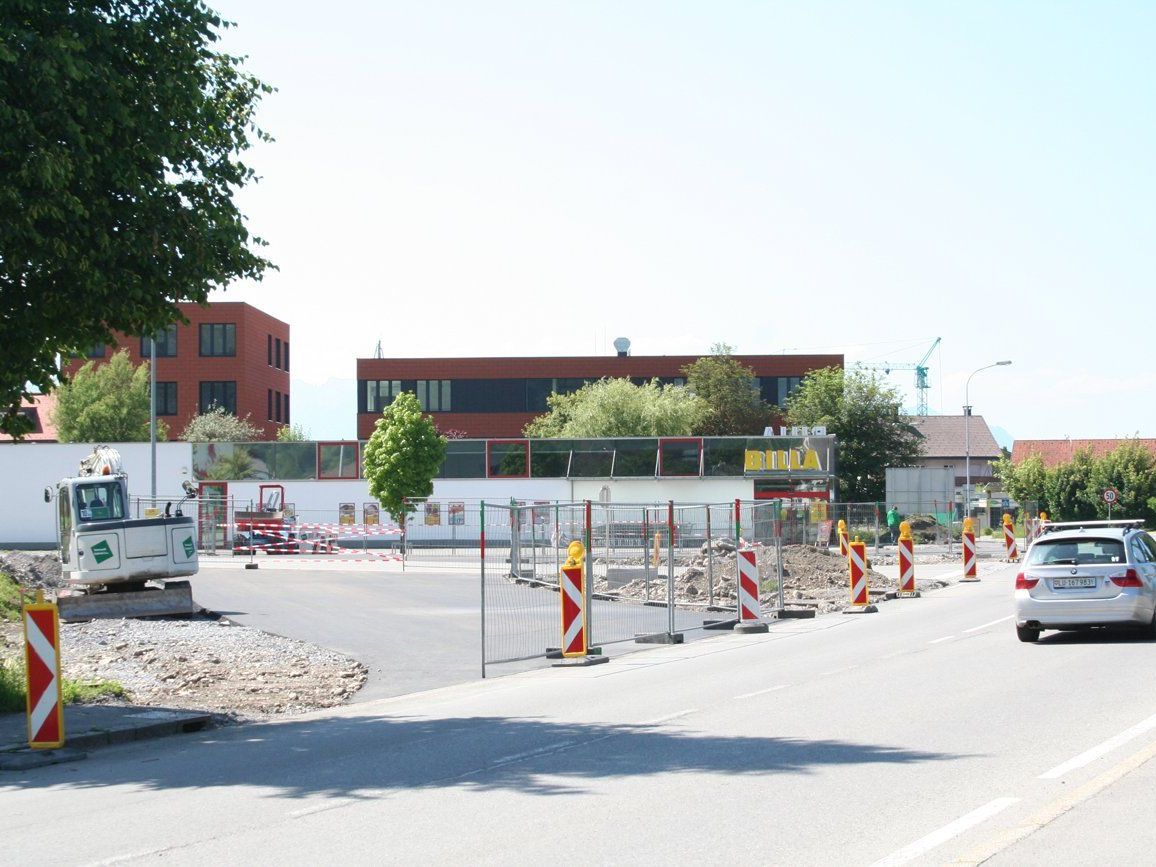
[364,392,445,525]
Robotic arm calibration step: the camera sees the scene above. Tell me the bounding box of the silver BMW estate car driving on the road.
[1015,520,1156,642]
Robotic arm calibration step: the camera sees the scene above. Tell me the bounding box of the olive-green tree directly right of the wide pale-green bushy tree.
[682,343,773,437]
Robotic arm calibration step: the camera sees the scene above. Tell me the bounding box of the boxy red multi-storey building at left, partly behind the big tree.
[66,302,290,439]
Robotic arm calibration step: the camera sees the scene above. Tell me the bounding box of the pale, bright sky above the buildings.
[209,0,1156,445]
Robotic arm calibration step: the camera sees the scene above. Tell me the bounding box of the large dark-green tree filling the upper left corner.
[0,0,271,435]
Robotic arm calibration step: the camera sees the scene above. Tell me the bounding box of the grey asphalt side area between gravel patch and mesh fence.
[192,557,712,703]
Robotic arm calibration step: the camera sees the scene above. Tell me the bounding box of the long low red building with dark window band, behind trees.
[357,353,843,439]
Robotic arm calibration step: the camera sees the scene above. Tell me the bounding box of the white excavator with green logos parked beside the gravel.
[44,445,200,621]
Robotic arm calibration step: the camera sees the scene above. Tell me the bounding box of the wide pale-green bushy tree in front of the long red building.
[524,378,707,438]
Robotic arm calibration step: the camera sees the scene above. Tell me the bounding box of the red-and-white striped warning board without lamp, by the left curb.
[24,591,65,749]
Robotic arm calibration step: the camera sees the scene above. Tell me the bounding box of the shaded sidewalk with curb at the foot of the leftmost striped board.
[0,704,213,772]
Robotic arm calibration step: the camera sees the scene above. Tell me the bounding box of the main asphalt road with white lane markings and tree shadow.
[0,559,1156,865]
